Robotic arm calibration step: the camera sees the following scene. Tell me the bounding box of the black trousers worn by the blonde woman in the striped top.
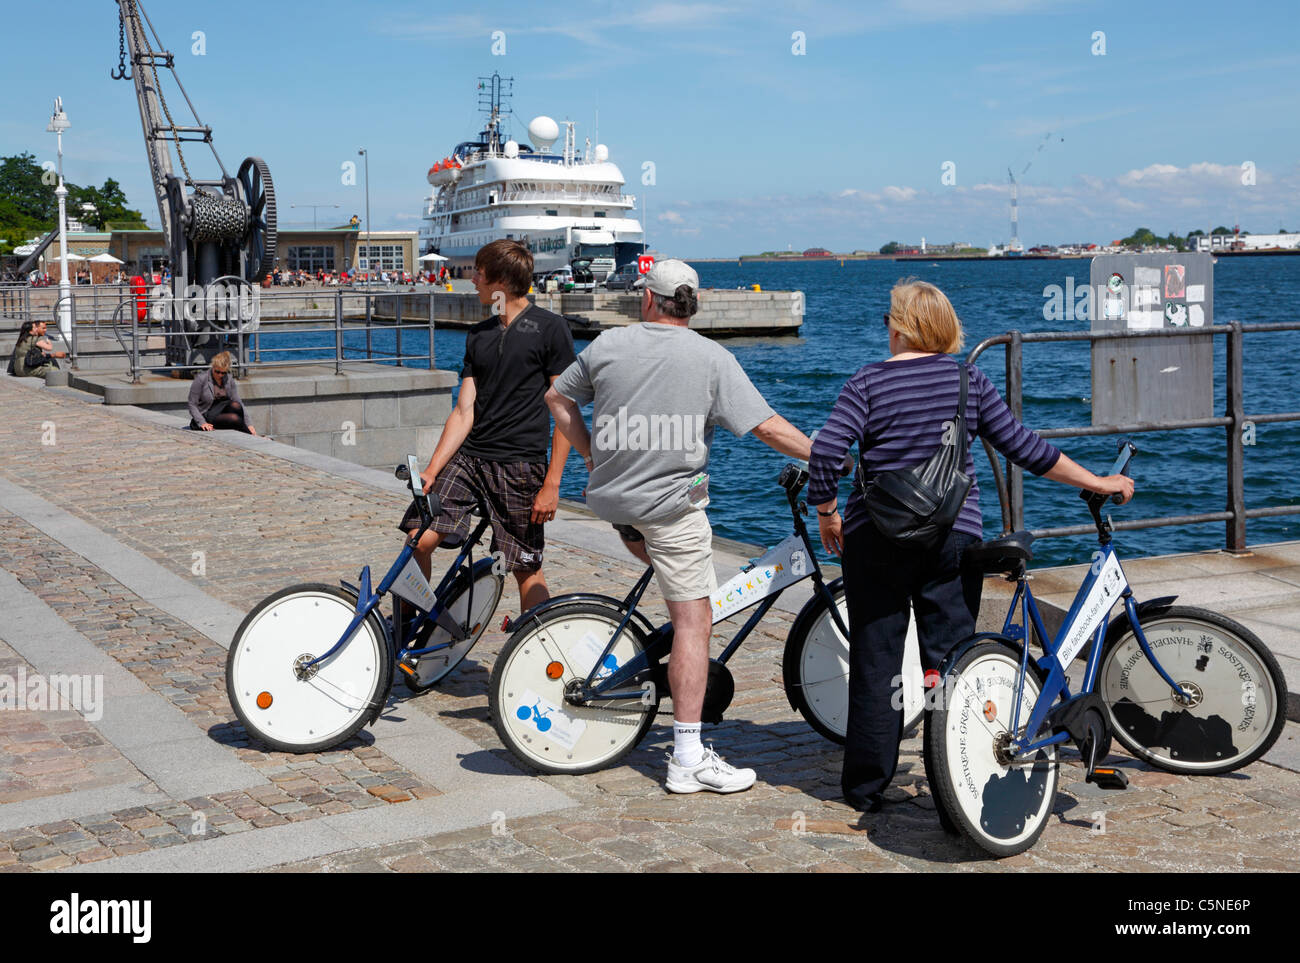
[841,522,983,810]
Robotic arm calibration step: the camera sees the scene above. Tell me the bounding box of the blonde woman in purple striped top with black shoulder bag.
[807,278,1134,812]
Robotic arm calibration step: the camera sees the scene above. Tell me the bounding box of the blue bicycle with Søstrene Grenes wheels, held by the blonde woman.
[924,443,1287,856]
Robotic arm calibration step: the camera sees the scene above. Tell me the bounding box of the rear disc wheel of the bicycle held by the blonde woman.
[926,643,1058,856]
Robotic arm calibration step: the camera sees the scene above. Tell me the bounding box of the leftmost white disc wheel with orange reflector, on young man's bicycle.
[226,585,393,752]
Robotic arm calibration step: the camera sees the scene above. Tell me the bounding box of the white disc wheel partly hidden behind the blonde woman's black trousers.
[784,589,926,745]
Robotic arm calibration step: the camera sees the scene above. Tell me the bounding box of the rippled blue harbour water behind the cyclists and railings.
[263,257,1300,564]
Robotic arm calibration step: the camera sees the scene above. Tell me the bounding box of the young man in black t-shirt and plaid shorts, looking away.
[399,240,575,612]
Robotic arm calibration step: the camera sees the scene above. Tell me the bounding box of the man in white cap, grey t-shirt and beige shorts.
[546,260,811,793]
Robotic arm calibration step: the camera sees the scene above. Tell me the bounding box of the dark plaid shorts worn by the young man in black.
[398,451,546,572]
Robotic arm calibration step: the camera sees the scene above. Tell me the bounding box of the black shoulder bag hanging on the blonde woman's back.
[859,361,974,550]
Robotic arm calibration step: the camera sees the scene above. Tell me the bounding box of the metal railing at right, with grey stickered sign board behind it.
[966,321,1300,552]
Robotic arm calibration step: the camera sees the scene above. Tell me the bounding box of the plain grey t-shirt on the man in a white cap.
[554,321,774,525]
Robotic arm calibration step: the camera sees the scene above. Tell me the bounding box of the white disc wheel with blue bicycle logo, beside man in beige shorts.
[489,603,659,773]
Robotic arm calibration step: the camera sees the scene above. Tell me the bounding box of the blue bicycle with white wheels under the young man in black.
[226,456,504,752]
